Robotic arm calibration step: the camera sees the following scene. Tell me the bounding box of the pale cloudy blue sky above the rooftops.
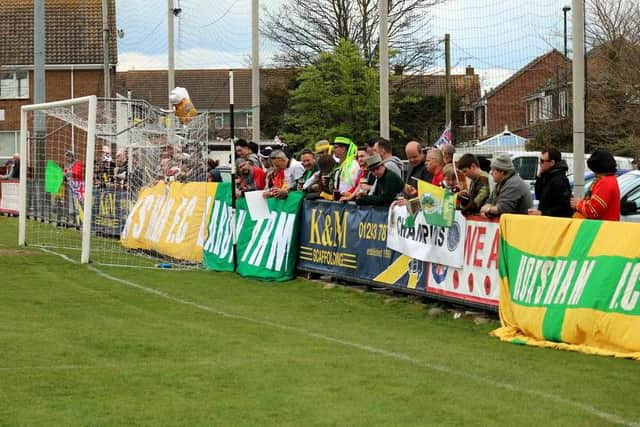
[116,0,571,90]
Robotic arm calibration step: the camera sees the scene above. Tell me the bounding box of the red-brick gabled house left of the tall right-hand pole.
[475,49,570,139]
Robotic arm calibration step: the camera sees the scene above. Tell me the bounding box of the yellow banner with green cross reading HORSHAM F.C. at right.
[492,215,640,360]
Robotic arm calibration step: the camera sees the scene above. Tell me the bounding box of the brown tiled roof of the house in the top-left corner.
[0,0,117,66]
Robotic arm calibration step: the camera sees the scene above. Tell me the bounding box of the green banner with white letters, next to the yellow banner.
[203,183,303,281]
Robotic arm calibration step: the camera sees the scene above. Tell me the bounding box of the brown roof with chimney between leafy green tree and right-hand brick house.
[393,68,480,105]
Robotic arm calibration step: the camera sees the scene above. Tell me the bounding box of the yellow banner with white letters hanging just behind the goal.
[120,182,217,262]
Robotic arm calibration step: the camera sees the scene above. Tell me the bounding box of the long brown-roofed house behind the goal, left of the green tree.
[116,68,298,140]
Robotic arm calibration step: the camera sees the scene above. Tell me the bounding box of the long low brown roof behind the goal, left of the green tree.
[116,68,298,111]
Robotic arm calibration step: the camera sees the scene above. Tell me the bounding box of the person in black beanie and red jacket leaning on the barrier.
[571,150,620,221]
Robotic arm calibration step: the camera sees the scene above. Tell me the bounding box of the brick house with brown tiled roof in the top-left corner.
[0,0,117,161]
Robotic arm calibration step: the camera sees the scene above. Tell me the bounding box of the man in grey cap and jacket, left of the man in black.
[480,153,533,218]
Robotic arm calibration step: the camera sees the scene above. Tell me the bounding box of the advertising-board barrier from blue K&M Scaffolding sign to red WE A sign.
[298,200,499,310]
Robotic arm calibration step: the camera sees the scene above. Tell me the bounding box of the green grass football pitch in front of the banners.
[0,217,640,426]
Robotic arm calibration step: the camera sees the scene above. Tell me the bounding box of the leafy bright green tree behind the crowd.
[284,40,379,146]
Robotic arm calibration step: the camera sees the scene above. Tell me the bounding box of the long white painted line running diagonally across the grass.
[15,249,640,427]
